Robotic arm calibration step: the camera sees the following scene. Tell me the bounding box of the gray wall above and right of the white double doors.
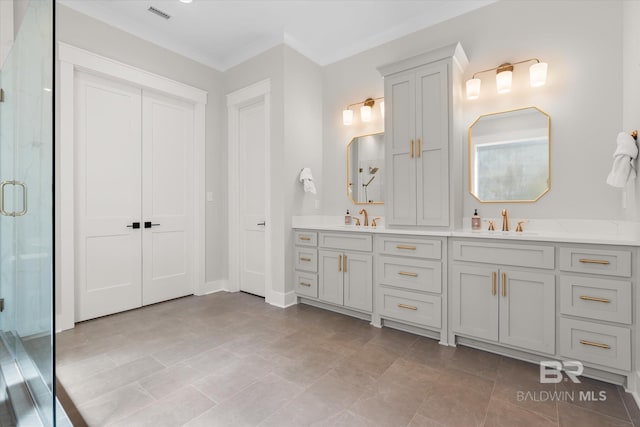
[56,4,228,288]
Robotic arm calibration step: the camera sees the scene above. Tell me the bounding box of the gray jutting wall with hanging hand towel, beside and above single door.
[224,45,322,293]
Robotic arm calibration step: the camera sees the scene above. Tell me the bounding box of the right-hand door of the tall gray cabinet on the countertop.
[415,62,449,226]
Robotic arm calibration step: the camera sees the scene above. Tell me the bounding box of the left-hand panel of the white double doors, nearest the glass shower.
[74,72,143,321]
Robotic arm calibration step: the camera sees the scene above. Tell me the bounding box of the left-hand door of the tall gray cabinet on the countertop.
[385,73,416,225]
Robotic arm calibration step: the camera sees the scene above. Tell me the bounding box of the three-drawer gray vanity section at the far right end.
[559,245,636,371]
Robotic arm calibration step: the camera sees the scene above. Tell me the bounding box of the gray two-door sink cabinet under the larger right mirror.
[450,240,556,354]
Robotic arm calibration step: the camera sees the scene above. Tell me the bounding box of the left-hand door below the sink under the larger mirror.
[451,266,498,341]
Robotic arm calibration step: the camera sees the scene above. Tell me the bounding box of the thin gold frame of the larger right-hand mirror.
[467,106,551,203]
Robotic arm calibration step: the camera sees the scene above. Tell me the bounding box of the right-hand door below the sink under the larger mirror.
[500,270,556,354]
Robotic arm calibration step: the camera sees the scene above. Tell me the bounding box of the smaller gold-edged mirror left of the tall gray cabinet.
[347,133,384,205]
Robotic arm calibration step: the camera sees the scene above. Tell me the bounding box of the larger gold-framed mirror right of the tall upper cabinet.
[468,107,551,203]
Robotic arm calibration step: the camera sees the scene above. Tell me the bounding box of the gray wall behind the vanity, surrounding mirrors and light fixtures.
[323,1,624,224]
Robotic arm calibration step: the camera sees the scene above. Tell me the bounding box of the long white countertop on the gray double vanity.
[292,216,640,246]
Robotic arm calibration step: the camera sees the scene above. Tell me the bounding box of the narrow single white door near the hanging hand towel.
[238,98,268,296]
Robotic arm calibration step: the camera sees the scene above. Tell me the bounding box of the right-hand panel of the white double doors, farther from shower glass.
[142,91,194,305]
